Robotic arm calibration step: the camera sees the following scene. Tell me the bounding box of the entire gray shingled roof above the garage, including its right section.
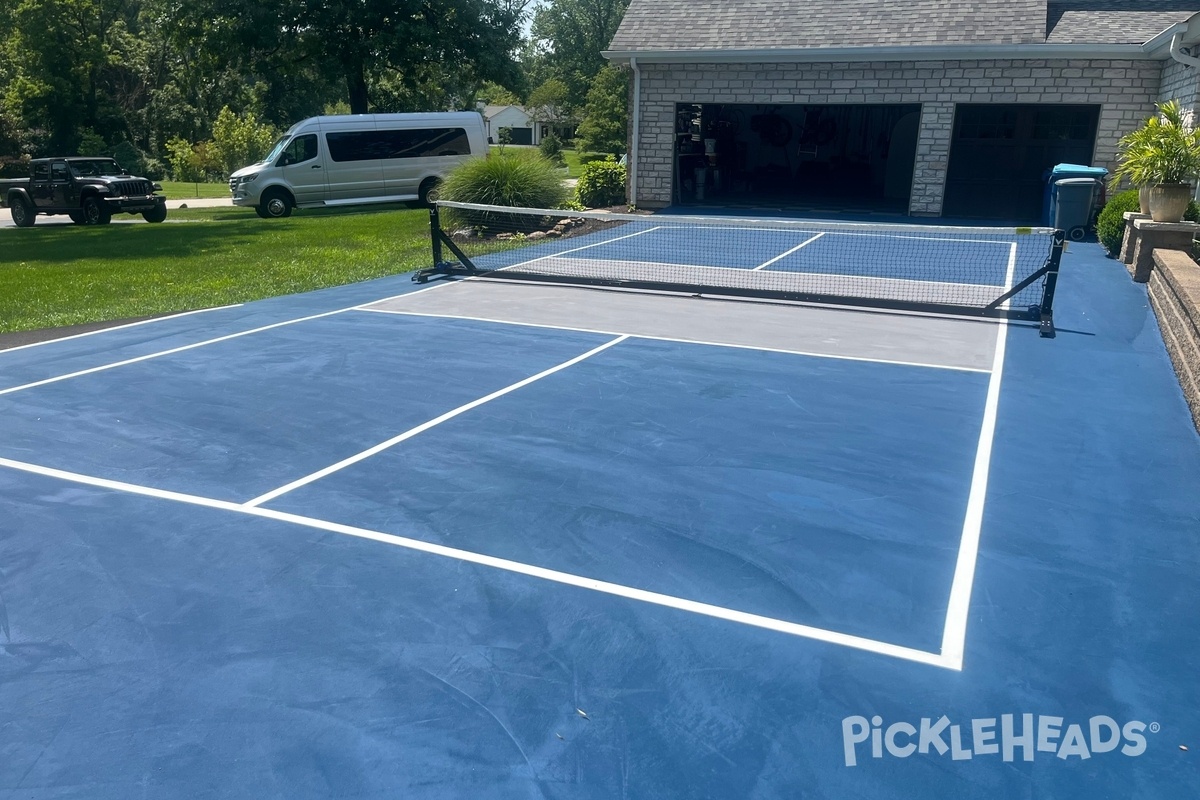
[610,0,1200,52]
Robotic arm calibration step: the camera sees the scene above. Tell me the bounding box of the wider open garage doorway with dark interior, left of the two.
[674,103,920,213]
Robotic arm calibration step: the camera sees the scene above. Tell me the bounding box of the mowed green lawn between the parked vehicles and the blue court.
[0,207,432,332]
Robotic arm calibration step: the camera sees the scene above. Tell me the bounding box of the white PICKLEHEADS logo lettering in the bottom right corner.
[841,714,1159,766]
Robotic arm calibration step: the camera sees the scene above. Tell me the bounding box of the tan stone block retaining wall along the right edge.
[1150,249,1200,431]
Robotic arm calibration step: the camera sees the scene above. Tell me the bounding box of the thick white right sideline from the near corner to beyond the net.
[942,268,1016,669]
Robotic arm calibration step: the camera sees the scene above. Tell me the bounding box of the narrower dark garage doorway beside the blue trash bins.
[942,103,1100,224]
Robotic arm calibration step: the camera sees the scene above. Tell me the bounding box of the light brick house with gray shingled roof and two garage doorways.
[606,0,1200,221]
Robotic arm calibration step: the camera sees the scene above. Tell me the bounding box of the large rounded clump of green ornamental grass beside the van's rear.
[440,150,568,228]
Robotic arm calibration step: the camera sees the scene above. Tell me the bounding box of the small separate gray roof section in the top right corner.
[1046,0,1200,44]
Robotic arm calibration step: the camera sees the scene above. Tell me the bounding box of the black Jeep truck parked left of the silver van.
[0,157,167,228]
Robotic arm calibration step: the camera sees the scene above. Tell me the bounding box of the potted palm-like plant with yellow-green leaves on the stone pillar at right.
[1112,100,1200,222]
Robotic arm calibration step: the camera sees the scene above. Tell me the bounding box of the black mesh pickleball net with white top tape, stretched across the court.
[431,201,1056,317]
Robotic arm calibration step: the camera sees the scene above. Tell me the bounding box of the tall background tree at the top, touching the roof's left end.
[529,0,629,107]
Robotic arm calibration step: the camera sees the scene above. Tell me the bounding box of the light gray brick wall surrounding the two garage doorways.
[635,60,1166,216]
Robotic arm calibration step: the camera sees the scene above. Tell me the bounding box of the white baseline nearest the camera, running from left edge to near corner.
[0,458,959,669]
